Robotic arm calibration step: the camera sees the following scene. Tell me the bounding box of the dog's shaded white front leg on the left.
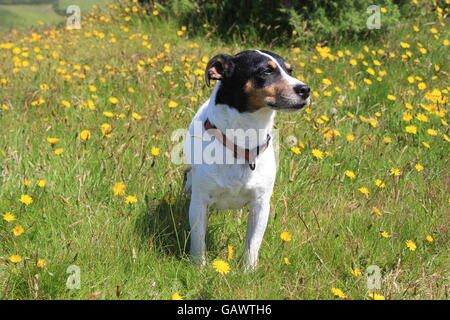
[189,193,208,265]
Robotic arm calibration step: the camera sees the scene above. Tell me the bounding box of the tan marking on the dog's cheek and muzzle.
[244,80,293,112]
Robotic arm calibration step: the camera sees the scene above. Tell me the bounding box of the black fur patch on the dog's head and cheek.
[211,50,290,112]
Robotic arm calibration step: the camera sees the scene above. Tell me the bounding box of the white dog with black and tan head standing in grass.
[184,50,310,270]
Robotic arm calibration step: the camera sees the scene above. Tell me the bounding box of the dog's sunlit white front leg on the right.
[244,196,270,271]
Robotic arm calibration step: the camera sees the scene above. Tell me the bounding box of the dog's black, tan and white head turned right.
[205,50,310,112]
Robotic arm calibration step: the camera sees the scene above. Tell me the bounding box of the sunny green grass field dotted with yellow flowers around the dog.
[0,0,450,299]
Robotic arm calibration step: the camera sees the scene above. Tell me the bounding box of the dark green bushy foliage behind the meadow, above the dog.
[141,0,408,43]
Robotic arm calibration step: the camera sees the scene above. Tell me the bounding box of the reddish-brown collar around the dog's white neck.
[204,119,272,170]
